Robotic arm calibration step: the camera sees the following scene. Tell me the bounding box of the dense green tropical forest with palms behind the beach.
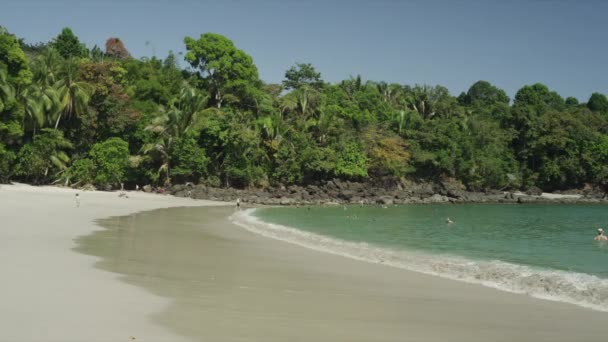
[0,28,608,190]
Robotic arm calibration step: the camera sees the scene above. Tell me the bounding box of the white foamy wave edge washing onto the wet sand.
[230,209,608,312]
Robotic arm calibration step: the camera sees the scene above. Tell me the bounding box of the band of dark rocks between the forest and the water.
[167,179,606,205]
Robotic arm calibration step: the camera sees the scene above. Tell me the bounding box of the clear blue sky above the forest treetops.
[0,0,608,101]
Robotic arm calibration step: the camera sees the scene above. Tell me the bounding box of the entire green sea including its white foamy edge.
[231,204,608,311]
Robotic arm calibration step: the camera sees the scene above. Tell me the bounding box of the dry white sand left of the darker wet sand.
[0,185,226,342]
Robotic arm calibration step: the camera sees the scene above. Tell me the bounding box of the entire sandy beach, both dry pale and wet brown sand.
[0,186,608,341]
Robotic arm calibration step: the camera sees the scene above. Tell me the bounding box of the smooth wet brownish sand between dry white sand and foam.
[77,207,608,341]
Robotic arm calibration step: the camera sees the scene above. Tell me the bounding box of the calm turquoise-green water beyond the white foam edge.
[256,204,608,278]
